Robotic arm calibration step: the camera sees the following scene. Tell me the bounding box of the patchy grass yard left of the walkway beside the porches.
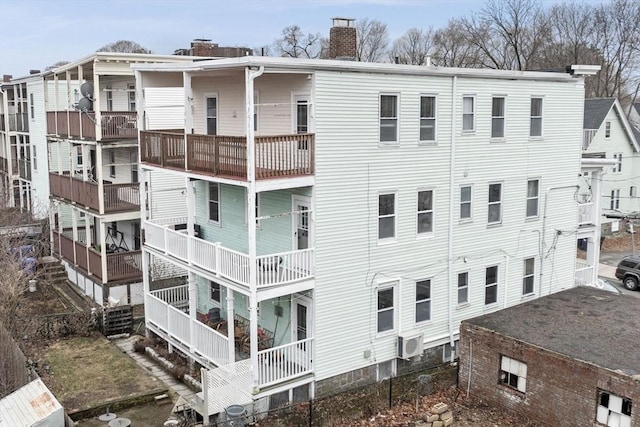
[40,335,160,411]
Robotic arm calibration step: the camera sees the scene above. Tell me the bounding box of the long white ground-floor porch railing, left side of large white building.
[145,286,229,366]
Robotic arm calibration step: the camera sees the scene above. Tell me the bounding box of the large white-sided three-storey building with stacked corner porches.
[133,22,596,418]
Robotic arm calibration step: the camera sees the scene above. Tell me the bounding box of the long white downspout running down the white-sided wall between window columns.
[447,75,458,361]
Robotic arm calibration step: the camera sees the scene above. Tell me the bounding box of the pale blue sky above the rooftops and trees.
[0,0,600,77]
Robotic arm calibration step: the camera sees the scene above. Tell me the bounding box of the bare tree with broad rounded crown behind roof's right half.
[462,0,549,70]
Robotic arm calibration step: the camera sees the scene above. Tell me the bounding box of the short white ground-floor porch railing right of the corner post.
[258,338,313,387]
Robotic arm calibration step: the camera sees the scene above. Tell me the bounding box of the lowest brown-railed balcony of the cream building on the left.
[52,231,142,283]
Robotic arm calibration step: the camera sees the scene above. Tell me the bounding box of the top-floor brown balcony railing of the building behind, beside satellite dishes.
[47,111,138,140]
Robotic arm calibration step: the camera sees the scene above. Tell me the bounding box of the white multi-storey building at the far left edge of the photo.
[0,70,49,219]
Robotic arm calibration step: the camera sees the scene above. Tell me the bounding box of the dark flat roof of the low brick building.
[467,287,640,376]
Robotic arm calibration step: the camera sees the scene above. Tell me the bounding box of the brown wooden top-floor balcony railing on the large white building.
[140,131,315,180]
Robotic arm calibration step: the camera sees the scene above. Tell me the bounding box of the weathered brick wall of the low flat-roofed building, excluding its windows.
[458,322,640,426]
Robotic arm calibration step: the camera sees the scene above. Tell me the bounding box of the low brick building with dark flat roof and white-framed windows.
[458,287,640,427]
